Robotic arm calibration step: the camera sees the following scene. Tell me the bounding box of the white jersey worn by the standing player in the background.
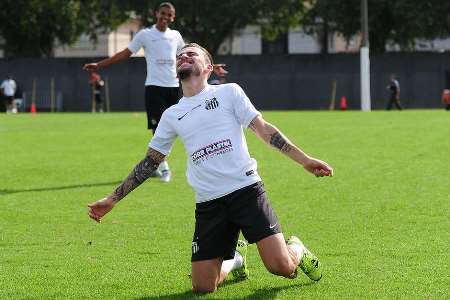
[128,25,184,87]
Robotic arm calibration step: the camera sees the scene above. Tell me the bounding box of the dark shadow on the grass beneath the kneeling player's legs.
[135,280,315,300]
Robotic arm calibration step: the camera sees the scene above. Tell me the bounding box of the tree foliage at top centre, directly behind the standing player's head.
[116,0,305,53]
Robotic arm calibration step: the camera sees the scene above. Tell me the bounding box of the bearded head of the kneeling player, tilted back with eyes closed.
[176,47,212,80]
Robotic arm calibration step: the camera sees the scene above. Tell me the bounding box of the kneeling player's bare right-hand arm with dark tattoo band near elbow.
[248,116,333,177]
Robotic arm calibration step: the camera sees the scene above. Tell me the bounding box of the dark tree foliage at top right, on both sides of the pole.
[303,0,450,52]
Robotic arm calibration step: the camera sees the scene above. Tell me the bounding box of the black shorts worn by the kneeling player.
[191,182,281,261]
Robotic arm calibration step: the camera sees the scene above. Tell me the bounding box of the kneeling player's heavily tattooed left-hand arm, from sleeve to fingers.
[88,148,165,222]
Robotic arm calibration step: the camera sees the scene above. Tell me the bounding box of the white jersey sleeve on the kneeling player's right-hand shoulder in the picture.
[230,83,261,128]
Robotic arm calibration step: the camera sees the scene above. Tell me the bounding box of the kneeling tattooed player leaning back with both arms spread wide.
[89,43,333,293]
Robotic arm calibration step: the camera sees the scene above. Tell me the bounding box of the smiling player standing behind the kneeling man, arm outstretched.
[83,2,227,182]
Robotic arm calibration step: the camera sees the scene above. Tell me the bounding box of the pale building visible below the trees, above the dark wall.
[0,18,450,57]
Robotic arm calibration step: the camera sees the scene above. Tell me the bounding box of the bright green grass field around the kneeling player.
[0,110,450,299]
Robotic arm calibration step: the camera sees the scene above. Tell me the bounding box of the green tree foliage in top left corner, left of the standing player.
[0,0,127,57]
